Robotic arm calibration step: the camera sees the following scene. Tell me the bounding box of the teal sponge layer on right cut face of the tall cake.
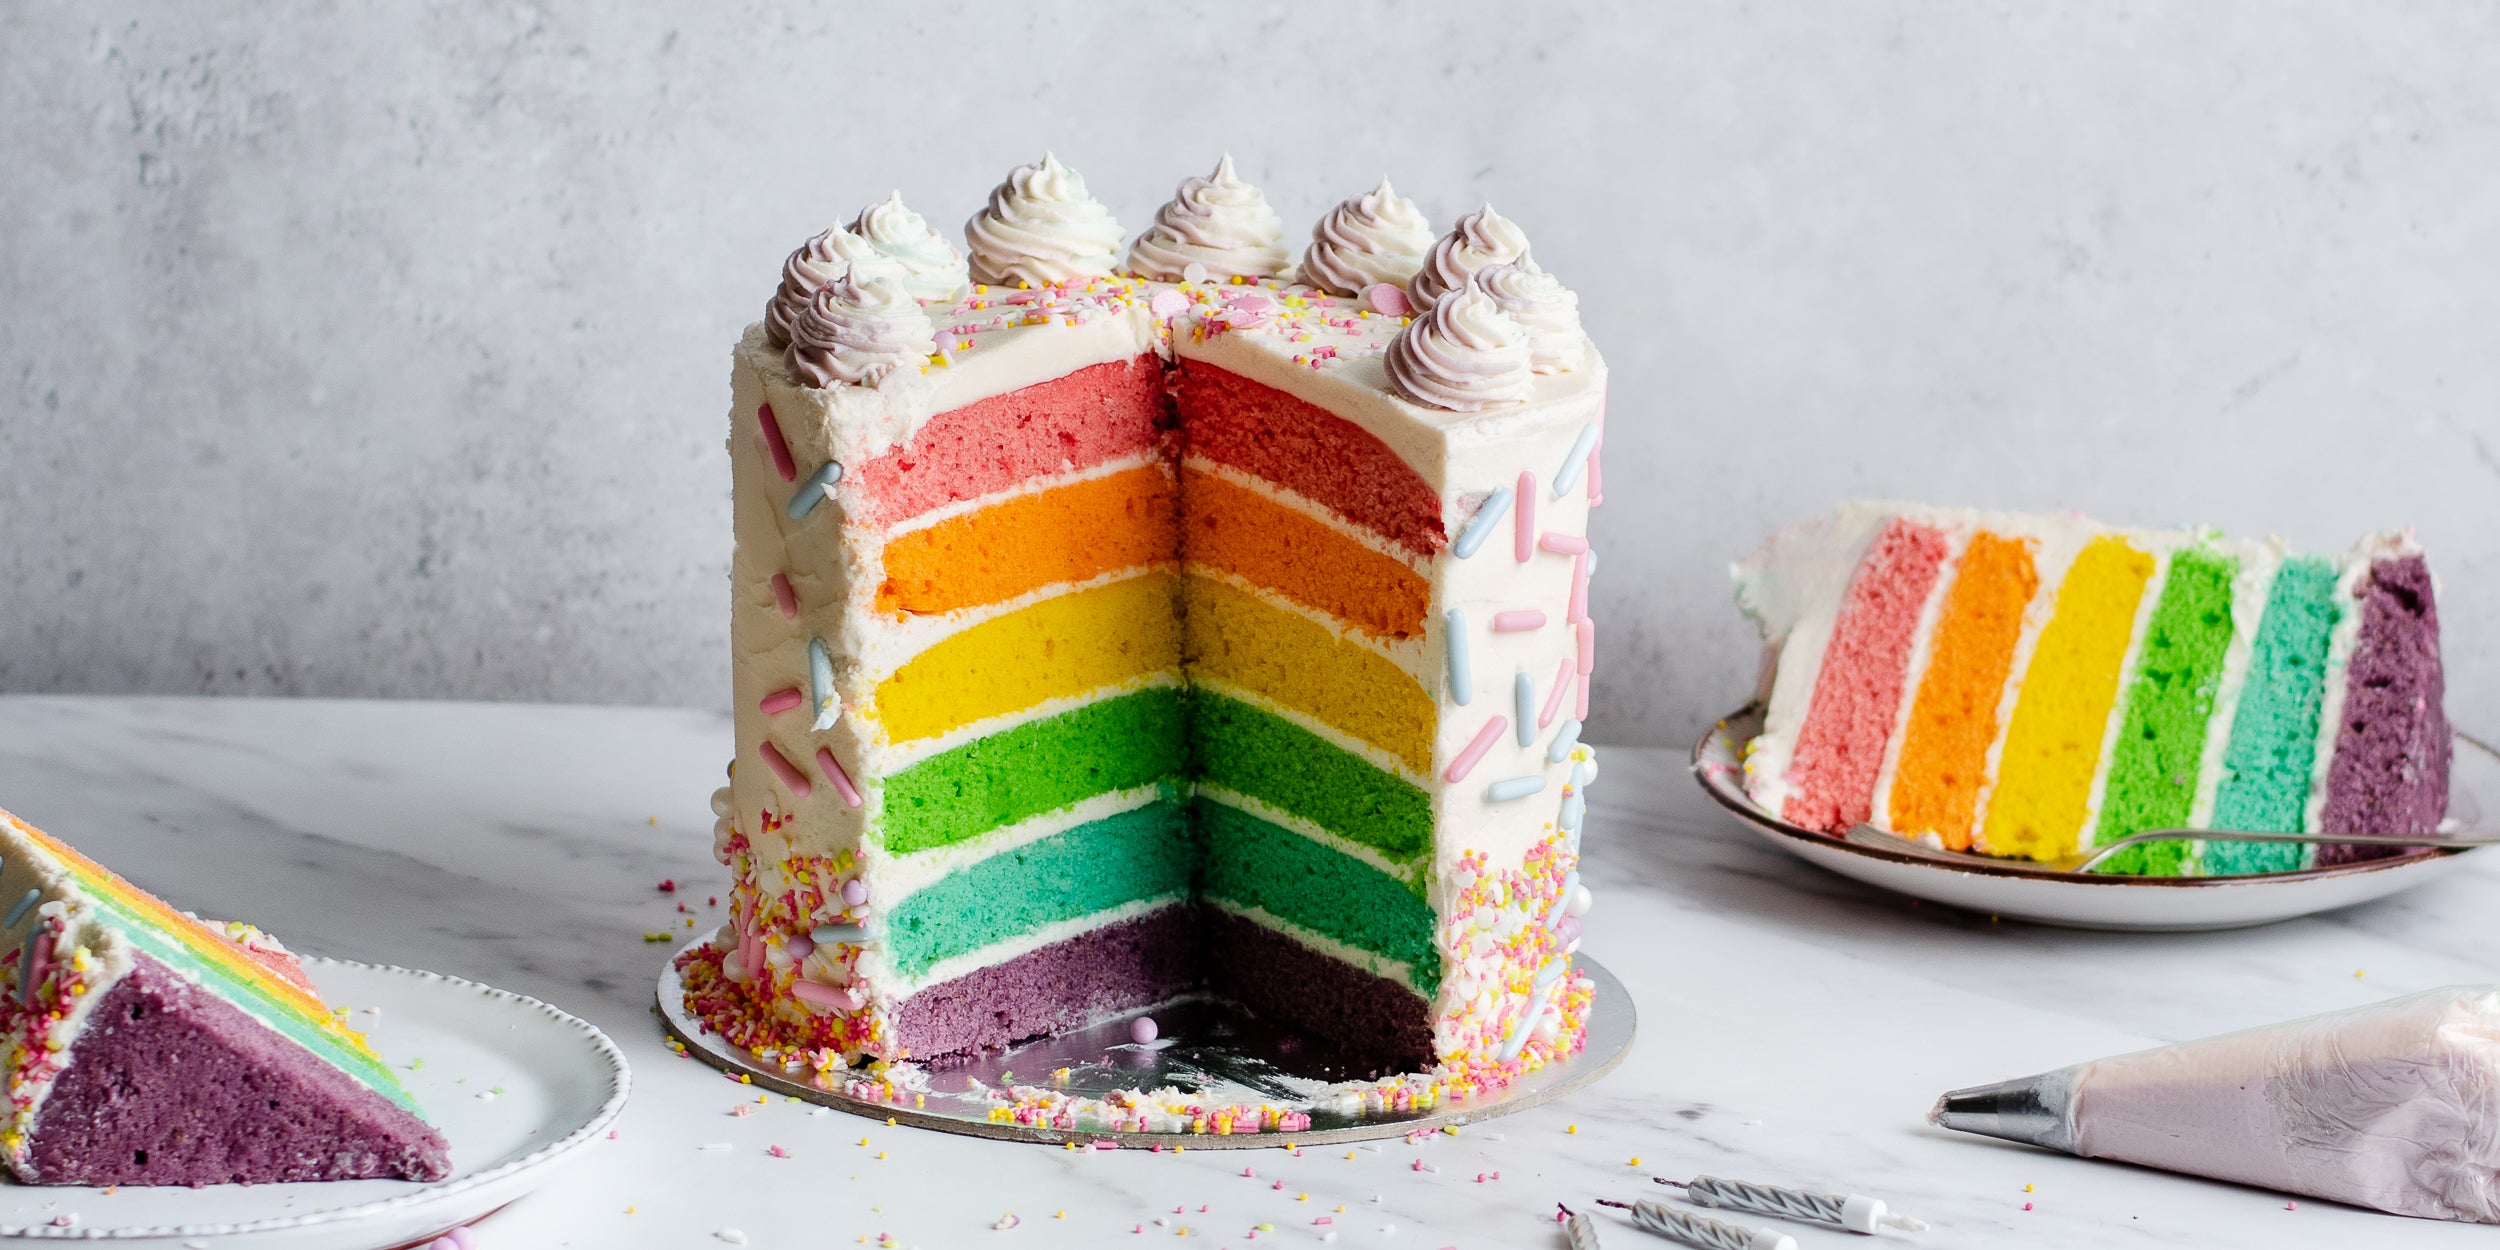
[1193,798,1440,998]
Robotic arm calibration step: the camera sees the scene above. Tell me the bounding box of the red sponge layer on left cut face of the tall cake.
[850,355,1170,525]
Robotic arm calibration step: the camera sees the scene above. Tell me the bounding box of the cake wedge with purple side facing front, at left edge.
[0,810,450,1185]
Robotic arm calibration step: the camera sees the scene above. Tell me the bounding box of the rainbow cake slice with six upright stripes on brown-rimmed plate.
[1735,503,2450,875]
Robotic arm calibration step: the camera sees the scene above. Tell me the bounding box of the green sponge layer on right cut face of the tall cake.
[1188,690,1433,860]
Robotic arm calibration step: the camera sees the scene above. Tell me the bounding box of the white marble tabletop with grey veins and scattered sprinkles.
[0,698,2500,1250]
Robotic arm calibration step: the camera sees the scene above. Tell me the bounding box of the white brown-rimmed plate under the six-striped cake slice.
[1693,708,2500,930]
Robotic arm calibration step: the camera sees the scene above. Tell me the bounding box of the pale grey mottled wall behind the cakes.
[0,0,2500,743]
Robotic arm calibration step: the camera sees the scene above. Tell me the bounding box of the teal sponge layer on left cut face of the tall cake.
[885,798,1198,978]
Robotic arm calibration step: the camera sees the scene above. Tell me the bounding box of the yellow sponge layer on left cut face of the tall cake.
[870,573,1180,743]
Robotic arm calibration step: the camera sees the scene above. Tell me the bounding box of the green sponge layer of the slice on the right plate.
[2095,548,2240,878]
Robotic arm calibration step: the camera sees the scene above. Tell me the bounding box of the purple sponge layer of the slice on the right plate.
[2318,555,2453,865]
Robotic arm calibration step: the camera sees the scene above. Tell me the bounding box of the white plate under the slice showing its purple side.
[0,960,630,1250]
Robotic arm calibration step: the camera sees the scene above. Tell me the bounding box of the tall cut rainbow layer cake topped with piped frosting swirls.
[683,160,1605,1085]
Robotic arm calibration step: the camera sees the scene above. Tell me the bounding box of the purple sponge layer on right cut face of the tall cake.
[1198,908,1433,1073]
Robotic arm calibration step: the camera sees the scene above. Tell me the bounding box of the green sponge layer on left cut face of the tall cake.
[880,688,1188,855]
